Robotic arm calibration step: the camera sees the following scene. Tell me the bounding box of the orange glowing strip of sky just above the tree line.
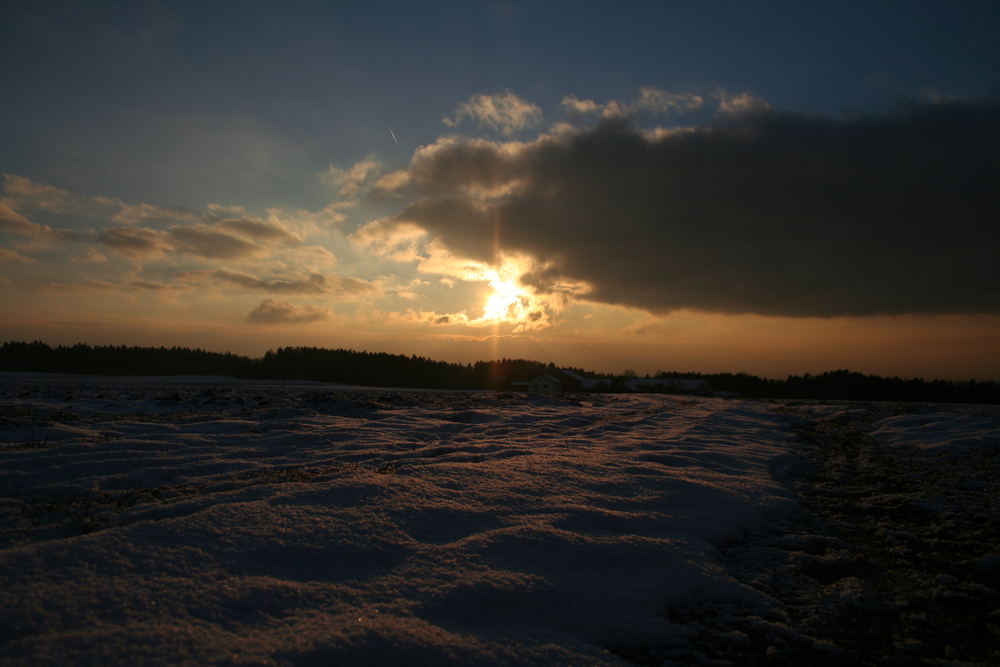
[0,307,1000,381]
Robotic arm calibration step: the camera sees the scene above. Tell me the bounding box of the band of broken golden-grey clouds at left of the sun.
[0,174,356,306]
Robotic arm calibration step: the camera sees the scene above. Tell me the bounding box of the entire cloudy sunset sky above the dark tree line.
[0,0,1000,380]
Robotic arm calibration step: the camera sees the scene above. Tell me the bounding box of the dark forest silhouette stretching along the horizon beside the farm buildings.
[0,341,1000,403]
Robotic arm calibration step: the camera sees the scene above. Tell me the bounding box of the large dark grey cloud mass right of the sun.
[396,102,1000,316]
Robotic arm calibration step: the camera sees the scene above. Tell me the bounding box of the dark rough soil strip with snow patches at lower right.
[613,406,1000,667]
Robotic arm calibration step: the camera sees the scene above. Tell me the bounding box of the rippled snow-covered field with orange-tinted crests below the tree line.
[0,375,1000,665]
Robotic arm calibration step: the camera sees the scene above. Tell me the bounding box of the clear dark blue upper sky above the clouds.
[9,2,1000,206]
